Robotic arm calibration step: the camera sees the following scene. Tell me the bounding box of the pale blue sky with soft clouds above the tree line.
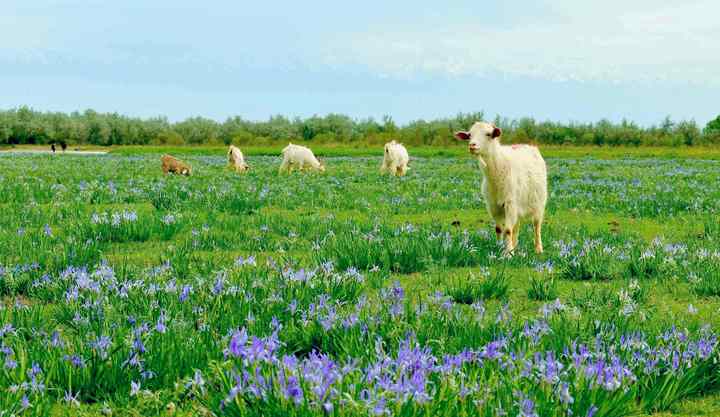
[0,0,720,125]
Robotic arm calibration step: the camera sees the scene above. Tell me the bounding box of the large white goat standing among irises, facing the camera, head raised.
[455,122,547,254]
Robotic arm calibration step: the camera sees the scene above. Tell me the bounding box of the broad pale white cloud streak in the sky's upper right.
[325,0,720,87]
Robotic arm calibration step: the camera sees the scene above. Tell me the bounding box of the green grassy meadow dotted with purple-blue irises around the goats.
[0,146,720,417]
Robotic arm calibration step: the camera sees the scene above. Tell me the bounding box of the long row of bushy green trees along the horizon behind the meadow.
[0,107,720,146]
